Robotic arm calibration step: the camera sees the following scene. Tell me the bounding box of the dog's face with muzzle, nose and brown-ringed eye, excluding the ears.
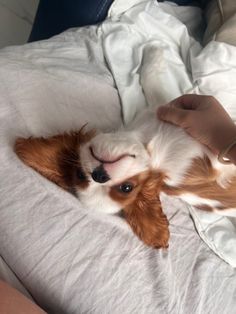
[78,133,150,213]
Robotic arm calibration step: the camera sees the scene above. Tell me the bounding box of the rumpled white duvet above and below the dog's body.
[102,0,236,267]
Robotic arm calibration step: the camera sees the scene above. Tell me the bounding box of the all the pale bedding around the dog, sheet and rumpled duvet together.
[0,0,236,314]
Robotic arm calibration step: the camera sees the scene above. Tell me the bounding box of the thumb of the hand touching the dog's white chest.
[157,105,186,126]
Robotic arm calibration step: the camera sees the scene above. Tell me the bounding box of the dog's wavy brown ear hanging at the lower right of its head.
[124,177,170,248]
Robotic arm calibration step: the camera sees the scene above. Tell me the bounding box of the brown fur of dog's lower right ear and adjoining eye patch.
[110,171,170,248]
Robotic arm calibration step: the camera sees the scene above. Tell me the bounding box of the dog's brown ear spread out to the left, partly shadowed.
[15,131,94,189]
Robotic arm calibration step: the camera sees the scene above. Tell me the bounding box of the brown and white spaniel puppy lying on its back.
[15,108,236,248]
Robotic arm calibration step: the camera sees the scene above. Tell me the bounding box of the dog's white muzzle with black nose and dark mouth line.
[80,133,150,186]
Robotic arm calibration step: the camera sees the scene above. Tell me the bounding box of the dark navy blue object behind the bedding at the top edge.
[29,0,201,42]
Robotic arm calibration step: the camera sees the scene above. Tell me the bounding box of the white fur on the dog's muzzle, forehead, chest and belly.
[80,103,236,213]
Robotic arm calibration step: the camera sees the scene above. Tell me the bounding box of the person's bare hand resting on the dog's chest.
[157,94,236,154]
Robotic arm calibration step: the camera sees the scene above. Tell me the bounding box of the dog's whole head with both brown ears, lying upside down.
[15,130,169,247]
